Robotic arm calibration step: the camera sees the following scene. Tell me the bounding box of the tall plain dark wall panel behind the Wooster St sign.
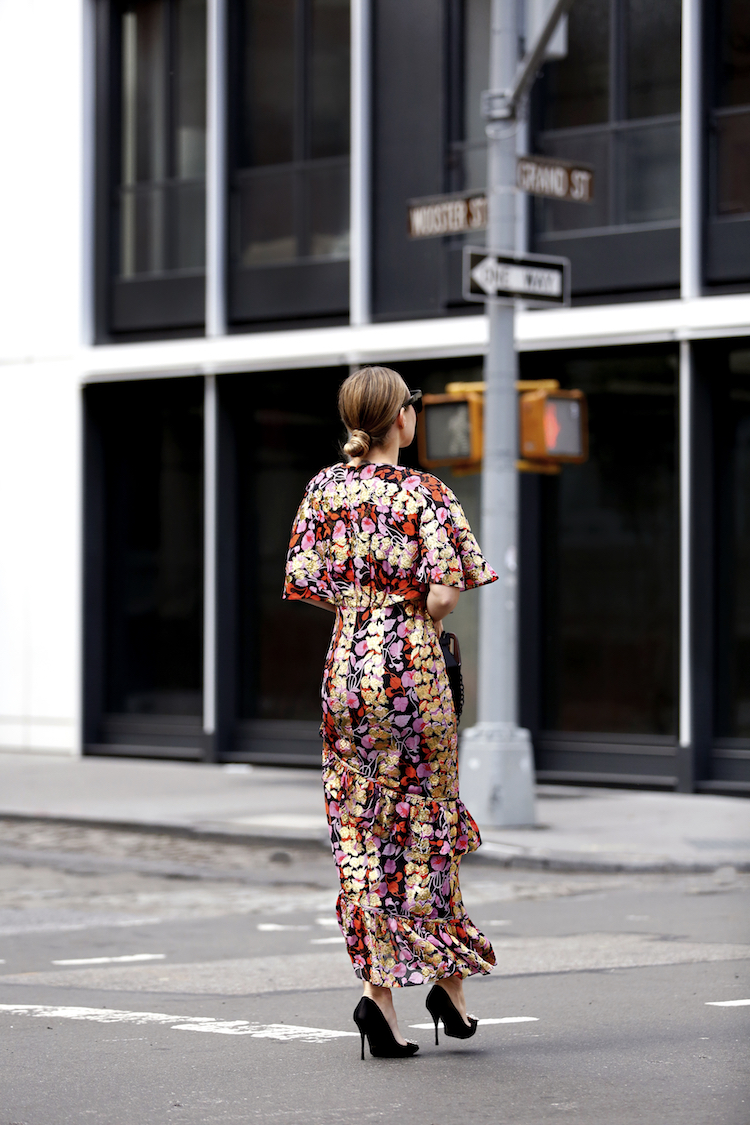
[372,0,445,320]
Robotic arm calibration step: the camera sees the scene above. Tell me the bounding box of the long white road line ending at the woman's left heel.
[0,1004,359,1043]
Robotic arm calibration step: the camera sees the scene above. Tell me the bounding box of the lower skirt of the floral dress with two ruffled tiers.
[323,749,495,988]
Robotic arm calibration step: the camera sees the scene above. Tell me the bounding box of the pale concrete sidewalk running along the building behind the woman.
[0,754,750,872]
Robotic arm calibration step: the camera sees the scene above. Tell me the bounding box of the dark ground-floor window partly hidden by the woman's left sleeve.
[229,369,345,723]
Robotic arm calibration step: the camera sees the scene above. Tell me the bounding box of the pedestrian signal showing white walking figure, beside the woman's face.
[417,393,482,469]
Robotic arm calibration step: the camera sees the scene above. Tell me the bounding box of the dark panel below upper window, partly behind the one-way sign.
[534,226,679,296]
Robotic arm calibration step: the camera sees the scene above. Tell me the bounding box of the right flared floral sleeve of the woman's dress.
[417,474,497,590]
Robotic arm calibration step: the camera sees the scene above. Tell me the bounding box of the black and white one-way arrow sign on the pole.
[463,246,570,305]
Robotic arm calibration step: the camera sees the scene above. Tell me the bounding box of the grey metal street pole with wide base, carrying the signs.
[461,0,534,826]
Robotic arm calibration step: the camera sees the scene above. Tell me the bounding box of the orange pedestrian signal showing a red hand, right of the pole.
[518,390,588,465]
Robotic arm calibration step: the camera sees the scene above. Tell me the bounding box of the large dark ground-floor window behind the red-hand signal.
[523,350,678,735]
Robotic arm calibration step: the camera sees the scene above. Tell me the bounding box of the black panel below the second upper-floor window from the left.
[229,261,349,322]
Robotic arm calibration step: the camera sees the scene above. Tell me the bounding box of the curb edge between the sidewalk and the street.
[0,812,750,881]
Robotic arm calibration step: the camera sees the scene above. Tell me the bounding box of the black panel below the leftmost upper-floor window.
[111,276,206,332]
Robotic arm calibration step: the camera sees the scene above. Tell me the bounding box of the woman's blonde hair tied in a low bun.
[338,367,409,458]
